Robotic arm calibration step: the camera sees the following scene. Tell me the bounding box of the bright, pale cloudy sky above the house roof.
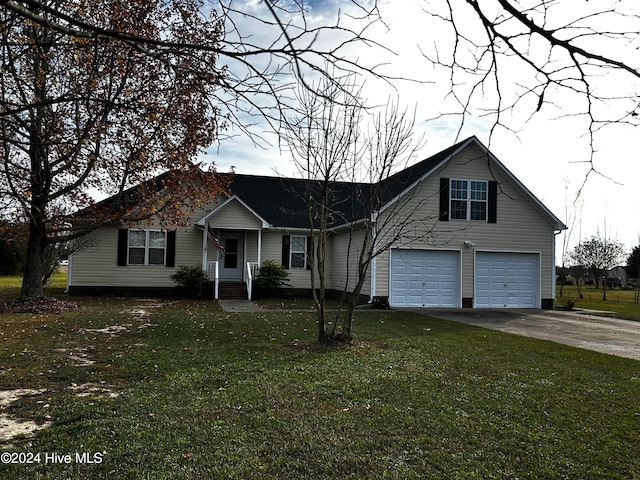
[205,0,640,262]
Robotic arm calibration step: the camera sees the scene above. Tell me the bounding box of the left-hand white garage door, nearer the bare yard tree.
[389,249,460,307]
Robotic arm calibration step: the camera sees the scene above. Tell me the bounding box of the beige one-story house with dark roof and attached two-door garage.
[69,137,566,308]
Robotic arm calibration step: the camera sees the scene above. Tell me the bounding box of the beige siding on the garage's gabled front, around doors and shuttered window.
[376,142,555,298]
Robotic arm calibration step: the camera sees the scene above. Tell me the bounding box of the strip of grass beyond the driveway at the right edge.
[555,285,640,320]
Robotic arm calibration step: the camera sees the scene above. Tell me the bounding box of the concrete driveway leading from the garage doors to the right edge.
[408,308,640,360]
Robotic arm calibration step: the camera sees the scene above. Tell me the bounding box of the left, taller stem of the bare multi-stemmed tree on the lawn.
[282,72,363,341]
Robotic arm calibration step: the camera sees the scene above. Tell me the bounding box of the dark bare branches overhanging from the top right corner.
[417,0,640,181]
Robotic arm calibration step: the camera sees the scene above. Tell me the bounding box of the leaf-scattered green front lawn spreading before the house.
[0,284,640,479]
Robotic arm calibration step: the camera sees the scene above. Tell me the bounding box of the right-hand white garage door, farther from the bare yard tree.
[475,252,540,308]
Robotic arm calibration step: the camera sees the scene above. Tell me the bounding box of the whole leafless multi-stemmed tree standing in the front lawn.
[283,77,434,342]
